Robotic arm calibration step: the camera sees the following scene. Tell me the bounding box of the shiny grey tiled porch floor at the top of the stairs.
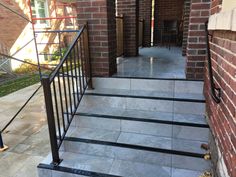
[114,47,186,79]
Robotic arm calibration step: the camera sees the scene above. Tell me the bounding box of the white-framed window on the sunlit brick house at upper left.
[31,0,50,27]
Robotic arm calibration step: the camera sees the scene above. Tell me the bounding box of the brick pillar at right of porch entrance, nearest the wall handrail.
[186,0,210,79]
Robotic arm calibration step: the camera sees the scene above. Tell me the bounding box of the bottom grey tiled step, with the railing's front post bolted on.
[38,152,209,177]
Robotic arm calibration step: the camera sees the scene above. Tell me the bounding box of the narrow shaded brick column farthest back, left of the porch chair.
[139,0,152,47]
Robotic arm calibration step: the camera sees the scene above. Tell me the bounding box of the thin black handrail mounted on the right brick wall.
[205,21,221,104]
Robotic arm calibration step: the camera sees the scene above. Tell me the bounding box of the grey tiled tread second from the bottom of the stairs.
[64,122,209,153]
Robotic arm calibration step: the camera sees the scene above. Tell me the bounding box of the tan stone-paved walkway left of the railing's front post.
[0,84,50,177]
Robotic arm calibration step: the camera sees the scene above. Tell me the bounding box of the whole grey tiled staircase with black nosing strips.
[38,78,211,177]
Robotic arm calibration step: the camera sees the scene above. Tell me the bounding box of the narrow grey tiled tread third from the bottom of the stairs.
[77,105,207,126]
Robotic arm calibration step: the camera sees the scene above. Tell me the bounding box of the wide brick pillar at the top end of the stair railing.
[76,0,116,76]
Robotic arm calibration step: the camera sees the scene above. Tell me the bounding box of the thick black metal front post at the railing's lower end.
[42,77,61,165]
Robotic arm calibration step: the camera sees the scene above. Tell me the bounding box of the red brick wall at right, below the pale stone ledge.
[204,31,236,177]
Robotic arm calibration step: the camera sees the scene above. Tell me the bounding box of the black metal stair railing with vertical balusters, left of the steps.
[42,25,92,165]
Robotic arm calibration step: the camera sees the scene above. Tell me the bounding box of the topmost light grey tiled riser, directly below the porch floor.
[93,78,203,94]
